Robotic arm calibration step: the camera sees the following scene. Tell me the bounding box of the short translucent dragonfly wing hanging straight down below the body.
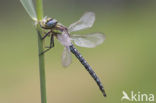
[62,47,72,67]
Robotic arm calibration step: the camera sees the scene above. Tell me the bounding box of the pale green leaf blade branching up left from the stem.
[20,0,37,21]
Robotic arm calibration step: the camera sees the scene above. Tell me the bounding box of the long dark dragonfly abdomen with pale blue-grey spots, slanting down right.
[70,45,106,96]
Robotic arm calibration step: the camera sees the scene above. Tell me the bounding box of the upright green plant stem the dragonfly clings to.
[36,0,47,103]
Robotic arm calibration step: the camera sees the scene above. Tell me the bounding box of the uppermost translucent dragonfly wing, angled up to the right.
[68,12,95,32]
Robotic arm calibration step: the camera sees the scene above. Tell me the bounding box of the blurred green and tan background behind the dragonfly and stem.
[0,0,156,103]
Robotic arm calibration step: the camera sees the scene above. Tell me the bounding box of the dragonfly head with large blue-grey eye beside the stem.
[40,17,57,29]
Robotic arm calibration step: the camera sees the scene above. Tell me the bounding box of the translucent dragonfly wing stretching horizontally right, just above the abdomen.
[71,33,105,48]
